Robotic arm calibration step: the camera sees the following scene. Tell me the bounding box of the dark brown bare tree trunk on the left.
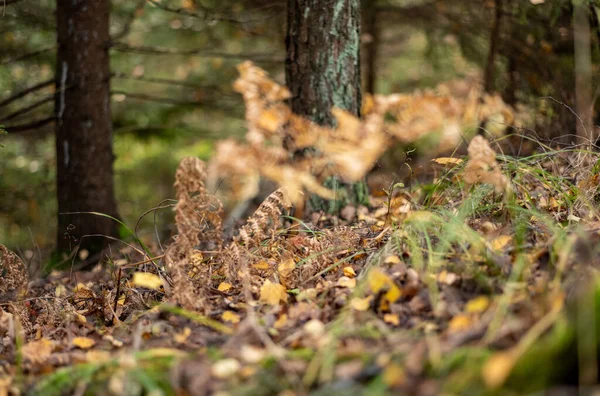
[55,0,118,253]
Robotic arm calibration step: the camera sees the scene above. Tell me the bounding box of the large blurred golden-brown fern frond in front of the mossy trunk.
[210,62,513,204]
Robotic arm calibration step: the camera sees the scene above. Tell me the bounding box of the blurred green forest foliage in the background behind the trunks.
[0,0,600,255]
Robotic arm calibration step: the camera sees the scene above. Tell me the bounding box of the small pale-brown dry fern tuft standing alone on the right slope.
[463,135,510,192]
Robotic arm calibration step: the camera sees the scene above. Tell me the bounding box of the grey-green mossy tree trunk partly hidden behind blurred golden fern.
[285,0,367,212]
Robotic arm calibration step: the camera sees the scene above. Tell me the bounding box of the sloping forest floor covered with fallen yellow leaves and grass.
[0,143,600,395]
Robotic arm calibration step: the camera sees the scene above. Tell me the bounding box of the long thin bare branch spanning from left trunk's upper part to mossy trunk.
[113,43,284,63]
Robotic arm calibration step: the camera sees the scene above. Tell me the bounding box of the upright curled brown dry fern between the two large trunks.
[165,157,223,309]
